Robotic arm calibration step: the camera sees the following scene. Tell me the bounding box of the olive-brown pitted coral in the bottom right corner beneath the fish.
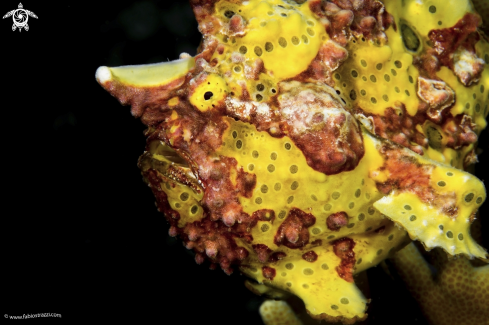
[392,244,489,325]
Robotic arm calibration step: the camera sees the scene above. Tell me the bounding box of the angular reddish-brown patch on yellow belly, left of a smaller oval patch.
[274,208,316,248]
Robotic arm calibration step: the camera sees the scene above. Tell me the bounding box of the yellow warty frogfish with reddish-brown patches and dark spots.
[96,0,489,323]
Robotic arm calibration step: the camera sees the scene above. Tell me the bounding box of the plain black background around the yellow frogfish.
[0,0,488,324]
